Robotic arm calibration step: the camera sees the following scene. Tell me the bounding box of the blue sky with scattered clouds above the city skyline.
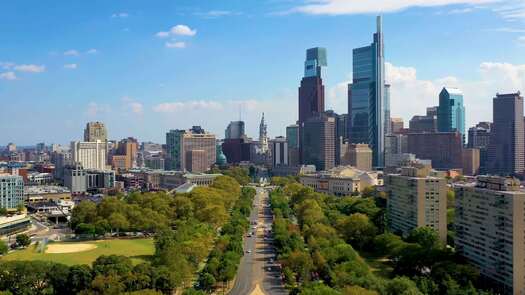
[0,0,525,145]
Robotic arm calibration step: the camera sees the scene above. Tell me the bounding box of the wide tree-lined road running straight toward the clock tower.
[230,188,288,295]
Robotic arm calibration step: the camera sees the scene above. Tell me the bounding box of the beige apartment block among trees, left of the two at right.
[385,165,447,243]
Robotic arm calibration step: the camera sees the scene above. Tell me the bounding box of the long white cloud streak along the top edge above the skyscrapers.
[292,0,498,15]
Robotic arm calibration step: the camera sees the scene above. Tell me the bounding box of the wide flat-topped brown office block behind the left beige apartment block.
[407,132,463,169]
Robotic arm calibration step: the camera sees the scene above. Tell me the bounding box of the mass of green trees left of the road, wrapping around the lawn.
[0,176,248,294]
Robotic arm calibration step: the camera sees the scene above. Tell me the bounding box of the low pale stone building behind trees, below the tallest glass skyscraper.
[299,166,383,196]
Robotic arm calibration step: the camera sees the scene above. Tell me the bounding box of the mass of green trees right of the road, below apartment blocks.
[271,178,489,295]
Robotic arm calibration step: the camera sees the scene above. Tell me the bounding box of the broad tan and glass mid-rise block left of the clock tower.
[166,126,216,172]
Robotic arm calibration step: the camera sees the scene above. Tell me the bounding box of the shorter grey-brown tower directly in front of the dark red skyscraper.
[301,114,336,170]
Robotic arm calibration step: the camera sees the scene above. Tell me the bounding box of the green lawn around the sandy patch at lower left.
[0,239,155,265]
